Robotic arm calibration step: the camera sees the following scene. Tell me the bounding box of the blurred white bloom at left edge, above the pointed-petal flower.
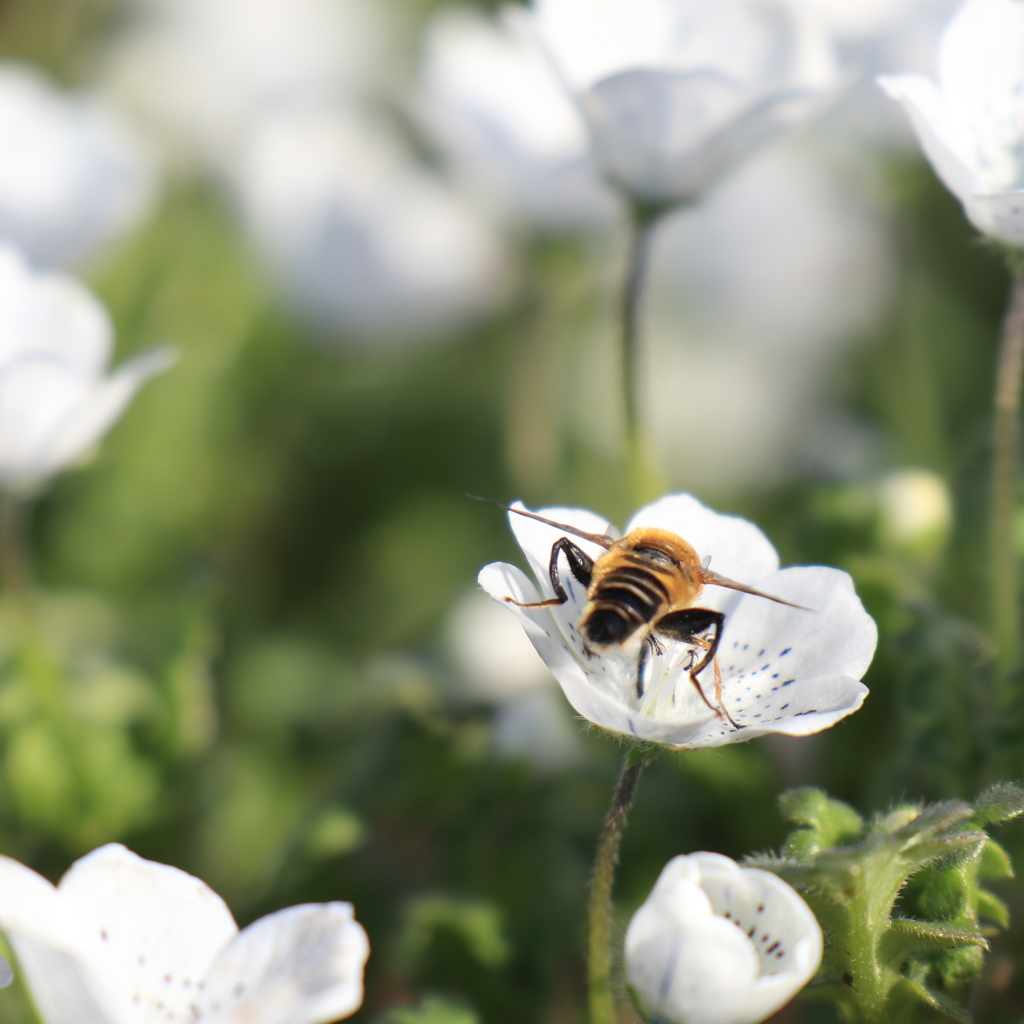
[0,62,154,266]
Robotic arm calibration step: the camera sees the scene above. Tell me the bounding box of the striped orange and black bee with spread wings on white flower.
[468,495,811,729]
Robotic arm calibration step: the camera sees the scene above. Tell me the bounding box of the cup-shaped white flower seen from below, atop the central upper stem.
[534,0,836,206]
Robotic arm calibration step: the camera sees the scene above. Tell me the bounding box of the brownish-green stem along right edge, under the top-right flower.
[990,270,1024,692]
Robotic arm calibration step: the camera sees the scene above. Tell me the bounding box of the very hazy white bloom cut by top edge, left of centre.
[108,0,388,166]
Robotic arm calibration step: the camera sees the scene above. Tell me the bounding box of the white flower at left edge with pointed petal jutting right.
[0,245,170,488]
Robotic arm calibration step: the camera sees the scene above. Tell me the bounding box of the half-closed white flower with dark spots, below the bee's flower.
[626,853,822,1024]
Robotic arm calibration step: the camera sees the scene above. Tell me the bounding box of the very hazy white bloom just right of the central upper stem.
[643,145,894,492]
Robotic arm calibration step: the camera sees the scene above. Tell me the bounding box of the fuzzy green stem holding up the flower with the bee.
[588,749,644,1024]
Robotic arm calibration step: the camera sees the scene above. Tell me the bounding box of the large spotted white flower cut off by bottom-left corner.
[0,843,370,1024]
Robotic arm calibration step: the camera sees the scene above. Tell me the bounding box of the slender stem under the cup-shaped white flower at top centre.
[620,205,664,505]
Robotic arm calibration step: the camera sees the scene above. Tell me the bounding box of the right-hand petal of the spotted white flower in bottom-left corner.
[202,903,370,1024]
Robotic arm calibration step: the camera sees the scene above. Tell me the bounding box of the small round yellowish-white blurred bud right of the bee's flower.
[878,469,953,551]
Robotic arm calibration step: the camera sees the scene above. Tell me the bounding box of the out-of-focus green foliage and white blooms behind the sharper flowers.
[0,0,1024,1024]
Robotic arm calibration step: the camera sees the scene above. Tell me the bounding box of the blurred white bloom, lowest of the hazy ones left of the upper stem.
[237,110,506,342]
